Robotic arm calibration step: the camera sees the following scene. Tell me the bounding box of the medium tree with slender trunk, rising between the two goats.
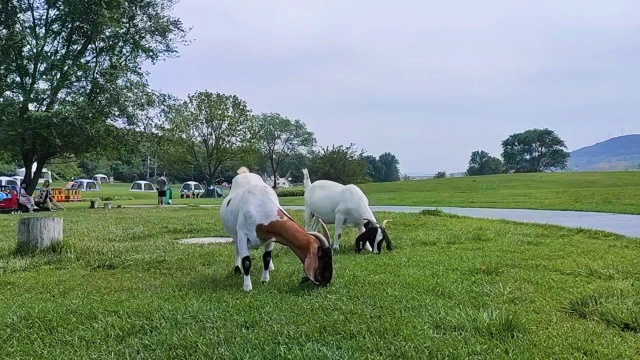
[256,113,316,189]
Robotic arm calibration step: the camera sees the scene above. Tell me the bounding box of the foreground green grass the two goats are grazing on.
[0,207,640,359]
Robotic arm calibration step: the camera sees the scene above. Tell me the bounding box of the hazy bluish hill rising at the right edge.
[568,134,640,171]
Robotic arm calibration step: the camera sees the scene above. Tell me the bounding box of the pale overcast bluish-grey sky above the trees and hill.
[149,0,640,173]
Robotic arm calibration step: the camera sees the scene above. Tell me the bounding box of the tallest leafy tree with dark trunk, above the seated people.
[0,0,188,193]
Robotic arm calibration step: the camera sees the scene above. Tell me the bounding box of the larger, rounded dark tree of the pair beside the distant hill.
[502,128,570,173]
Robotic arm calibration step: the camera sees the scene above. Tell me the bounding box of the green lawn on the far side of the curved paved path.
[53,171,640,214]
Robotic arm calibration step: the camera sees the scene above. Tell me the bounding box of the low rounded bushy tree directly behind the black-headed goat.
[309,144,367,184]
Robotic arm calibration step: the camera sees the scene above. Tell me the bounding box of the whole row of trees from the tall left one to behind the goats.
[0,0,400,193]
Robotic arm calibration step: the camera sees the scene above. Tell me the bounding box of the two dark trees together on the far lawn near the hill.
[467,128,570,176]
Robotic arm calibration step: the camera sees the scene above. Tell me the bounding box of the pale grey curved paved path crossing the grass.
[283,205,640,238]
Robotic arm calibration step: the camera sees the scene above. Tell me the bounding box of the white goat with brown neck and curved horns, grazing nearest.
[220,167,333,291]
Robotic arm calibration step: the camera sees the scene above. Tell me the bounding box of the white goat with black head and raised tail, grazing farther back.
[302,169,393,254]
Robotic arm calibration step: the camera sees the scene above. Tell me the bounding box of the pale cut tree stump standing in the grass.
[18,217,63,249]
